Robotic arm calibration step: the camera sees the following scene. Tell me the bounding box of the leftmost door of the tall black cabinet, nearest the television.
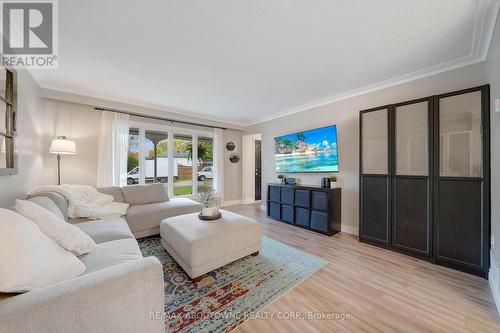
[359,108,390,244]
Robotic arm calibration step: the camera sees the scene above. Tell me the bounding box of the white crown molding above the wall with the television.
[247,0,500,126]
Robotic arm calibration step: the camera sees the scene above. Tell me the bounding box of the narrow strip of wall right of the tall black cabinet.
[486,13,500,311]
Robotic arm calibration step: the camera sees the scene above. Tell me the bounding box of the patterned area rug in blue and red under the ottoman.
[139,236,327,332]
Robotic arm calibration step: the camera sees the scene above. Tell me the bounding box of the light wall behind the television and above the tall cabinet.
[245,63,488,233]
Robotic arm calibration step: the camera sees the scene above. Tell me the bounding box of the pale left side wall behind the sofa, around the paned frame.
[0,70,45,208]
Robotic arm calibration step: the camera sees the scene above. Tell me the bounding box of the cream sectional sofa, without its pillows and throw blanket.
[0,184,201,333]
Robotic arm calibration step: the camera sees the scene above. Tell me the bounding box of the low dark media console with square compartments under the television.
[267,183,342,236]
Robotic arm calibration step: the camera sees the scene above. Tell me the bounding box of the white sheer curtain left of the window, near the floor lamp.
[97,111,129,187]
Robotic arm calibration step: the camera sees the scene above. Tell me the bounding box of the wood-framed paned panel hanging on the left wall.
[0,69,17,175]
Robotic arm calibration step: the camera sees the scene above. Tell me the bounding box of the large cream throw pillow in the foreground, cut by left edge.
[0,208,85,293]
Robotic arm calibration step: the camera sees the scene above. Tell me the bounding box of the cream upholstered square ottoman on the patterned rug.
[160,210,262,282]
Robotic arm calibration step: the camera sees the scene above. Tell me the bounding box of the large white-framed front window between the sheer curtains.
[127,122,215,196]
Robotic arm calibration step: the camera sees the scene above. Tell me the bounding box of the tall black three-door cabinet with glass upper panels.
[359,85,490,277]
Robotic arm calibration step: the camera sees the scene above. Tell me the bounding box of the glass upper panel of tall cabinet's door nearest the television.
[361,109,389,174]
